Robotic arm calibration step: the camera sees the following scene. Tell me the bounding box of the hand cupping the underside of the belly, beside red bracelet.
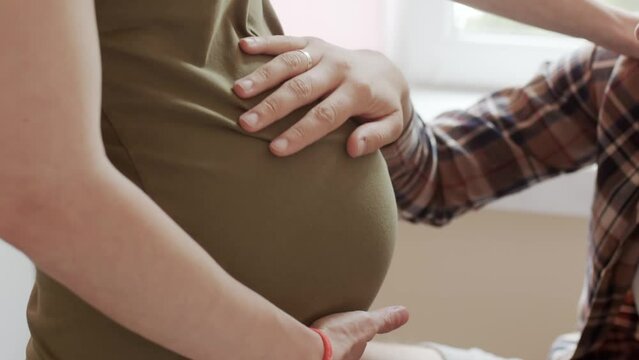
[313,306,409,360]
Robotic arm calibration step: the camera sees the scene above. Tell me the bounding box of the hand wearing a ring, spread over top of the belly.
[234,36,411,157]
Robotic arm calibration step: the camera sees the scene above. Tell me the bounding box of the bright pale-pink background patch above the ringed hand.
[271,0,384,50]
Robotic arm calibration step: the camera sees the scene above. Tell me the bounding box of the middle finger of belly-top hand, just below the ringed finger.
[240,65,338,132]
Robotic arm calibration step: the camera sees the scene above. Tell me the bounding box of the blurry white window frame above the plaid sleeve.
[386,0,584,89]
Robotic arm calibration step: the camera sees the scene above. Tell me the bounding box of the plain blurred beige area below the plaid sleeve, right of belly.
[374,210,588,360]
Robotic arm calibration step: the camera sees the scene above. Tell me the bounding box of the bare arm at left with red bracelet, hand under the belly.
[0,0,408,360]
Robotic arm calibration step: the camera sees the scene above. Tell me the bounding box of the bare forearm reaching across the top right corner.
[456,0,639,56]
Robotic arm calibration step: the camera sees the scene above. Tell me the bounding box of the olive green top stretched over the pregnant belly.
[27,0,397,360]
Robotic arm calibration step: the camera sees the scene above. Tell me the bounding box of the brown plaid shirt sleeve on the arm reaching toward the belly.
[382,47,609,225]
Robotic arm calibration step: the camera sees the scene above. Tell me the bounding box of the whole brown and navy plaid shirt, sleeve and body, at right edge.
[383,47,639,360]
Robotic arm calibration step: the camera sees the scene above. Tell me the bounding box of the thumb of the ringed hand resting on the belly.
[346,111,404,157]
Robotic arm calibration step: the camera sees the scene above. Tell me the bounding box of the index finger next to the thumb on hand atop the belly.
[270,88,355,156]
